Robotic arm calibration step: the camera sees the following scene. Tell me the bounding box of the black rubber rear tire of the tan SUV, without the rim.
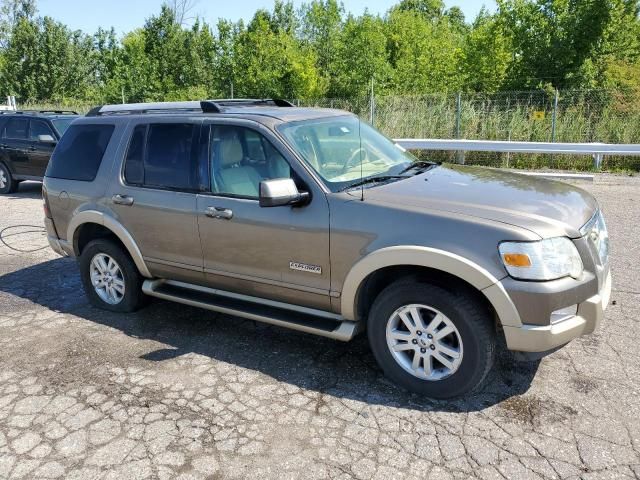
[79,238,146,313]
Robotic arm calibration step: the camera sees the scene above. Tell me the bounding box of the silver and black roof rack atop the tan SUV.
[87,98,294,117]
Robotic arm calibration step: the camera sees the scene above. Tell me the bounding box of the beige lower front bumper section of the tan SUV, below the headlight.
[503,272,611,352]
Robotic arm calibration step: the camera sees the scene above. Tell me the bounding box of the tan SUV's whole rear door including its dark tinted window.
[107,119,203,281]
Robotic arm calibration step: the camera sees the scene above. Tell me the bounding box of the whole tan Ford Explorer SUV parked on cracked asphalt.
[43,100,611,398]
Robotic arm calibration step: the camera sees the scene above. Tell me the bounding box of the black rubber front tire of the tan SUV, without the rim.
[367,280,496,399]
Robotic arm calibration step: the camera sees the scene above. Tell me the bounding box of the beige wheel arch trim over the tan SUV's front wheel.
[341,246,522,326]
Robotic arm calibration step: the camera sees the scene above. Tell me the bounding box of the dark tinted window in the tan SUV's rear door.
[124,123,198,190]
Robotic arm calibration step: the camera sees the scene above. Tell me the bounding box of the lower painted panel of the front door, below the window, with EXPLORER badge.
[197,195,331,309]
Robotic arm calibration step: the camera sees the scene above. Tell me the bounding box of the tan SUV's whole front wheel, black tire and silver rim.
[367,281,495,398]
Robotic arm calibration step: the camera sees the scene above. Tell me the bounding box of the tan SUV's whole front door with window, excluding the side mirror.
[198,121,331,310]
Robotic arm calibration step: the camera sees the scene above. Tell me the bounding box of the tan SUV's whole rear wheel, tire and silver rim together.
[79,238,144,312]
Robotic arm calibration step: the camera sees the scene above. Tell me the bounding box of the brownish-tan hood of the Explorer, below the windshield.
[365,165,598,238]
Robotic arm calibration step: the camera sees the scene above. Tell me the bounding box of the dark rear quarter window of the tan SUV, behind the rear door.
[45,124,115,182]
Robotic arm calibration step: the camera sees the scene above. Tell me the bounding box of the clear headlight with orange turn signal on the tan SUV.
[498,237,583,280]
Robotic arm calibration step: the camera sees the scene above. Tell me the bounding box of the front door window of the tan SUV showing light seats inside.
[209,126,292,198]
